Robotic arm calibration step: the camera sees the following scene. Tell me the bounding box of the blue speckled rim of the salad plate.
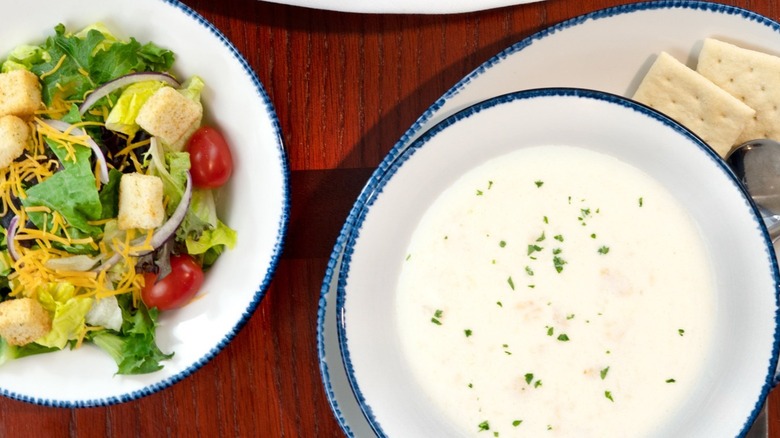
[0,0,290,408]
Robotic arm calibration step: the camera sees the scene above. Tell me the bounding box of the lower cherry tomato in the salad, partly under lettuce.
[141,254,203,310]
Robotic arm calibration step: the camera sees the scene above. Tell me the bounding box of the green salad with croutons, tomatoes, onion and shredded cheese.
[0,23,236,374]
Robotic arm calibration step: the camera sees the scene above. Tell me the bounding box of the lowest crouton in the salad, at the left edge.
[0,298,51,345]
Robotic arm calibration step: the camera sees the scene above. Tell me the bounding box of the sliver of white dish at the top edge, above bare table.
[266,0,543,14]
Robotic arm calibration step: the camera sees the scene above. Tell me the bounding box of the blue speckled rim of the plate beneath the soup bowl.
[317,1,780,437]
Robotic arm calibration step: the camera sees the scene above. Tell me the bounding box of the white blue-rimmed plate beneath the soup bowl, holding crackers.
[318,1,780,437]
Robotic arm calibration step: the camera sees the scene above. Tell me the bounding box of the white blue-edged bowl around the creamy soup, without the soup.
[336,88,780,437]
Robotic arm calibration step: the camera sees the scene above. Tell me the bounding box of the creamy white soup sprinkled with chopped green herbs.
[397,146,715,437]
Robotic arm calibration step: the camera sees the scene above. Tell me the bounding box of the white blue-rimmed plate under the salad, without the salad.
[0,0,289,407]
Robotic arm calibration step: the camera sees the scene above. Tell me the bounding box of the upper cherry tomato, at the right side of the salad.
[187,126,233,189]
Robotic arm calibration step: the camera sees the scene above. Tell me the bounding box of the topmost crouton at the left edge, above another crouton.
[0,70,41,117]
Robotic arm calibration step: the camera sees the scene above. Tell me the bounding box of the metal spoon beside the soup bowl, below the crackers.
[726,139,780,242]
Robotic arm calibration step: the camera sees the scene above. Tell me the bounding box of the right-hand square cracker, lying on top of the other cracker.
[696,38,780,143]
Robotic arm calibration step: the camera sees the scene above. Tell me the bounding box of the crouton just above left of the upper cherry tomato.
[135,87,203,150]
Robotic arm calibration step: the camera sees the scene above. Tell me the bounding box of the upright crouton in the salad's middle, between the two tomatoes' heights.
[117,173,165,230]
